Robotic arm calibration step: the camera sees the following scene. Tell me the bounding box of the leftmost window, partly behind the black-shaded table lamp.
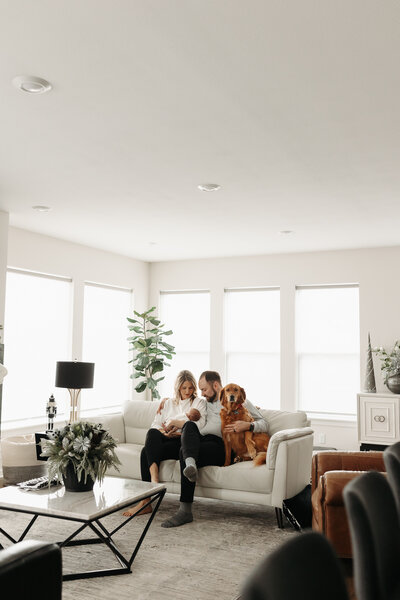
[2,269,72,422]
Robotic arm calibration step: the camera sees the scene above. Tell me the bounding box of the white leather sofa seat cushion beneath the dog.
[198,461,274,493]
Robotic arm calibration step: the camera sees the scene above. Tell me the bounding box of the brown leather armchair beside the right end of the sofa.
[311,451,385,558]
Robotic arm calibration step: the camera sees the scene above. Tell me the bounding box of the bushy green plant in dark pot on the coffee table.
[40,421,121,492]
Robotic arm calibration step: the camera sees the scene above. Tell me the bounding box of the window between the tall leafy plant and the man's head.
[159,292,210,397]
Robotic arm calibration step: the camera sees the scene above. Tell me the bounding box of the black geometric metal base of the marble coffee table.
[0,489,166,581]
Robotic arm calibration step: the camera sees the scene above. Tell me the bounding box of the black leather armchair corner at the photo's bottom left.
[0,540,62,600]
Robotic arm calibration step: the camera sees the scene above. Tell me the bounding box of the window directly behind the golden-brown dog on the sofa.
[225,289,280,409]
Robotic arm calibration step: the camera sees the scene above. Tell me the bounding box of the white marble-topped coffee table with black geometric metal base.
[0,477,166,580]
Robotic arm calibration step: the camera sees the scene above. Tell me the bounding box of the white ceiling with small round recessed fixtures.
[0,0,400,261]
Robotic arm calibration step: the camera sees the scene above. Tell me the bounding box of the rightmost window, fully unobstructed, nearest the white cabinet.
[296,285,360,415]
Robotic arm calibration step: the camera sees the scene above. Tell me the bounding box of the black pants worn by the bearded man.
[179,421,225,502]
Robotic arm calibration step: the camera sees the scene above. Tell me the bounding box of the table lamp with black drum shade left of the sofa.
[55,361,94,423]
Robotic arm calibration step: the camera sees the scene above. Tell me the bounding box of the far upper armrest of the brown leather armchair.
[312,451,385,492]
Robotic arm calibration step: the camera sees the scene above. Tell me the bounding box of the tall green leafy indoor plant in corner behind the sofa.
[127,306,175,400]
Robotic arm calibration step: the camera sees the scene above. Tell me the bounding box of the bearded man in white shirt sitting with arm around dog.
[161,371,268,527]
